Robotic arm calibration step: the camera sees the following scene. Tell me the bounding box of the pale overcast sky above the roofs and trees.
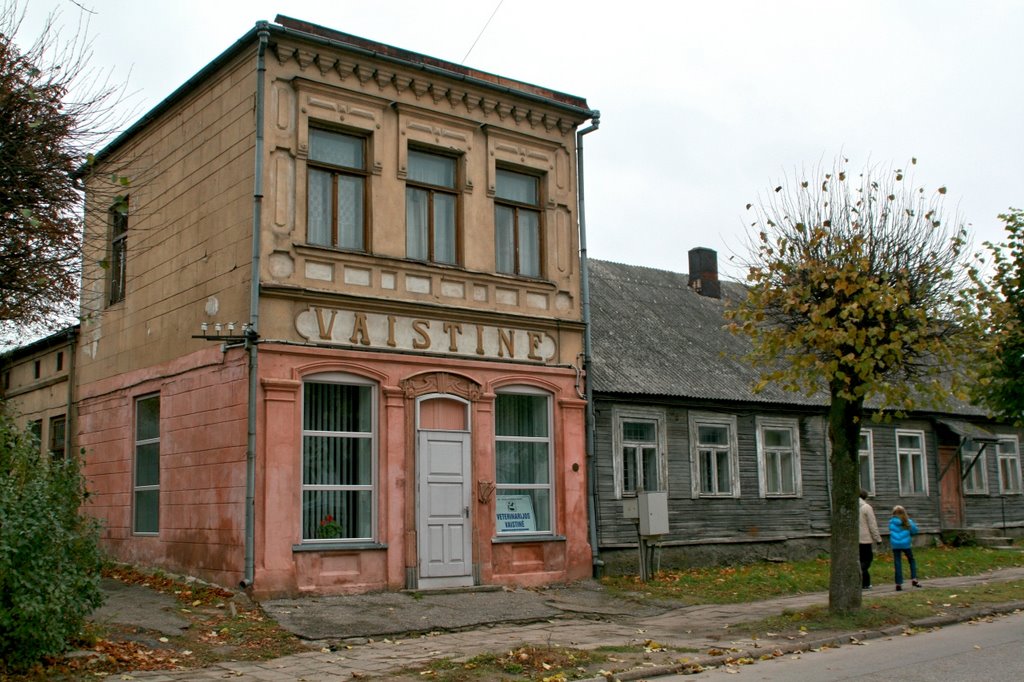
[20,0,1024,274]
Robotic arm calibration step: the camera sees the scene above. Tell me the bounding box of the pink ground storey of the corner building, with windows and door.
[78,344,592,597]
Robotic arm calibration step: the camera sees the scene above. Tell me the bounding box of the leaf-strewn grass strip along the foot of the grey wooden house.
[601,546,1024,605]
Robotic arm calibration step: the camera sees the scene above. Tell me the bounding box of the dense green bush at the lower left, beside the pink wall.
[0,411,101,677]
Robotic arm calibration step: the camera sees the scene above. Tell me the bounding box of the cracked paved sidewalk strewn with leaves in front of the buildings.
[109,568,1024,682]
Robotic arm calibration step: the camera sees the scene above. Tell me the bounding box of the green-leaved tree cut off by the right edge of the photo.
[962,208,1024,426]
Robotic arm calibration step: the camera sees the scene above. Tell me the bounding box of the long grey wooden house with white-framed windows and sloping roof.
[589,249,1024,572]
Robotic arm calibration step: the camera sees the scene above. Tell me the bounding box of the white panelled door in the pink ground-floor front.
[418,431,473,588]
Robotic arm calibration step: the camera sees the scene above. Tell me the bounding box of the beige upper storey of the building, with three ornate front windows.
[80,17,593,385]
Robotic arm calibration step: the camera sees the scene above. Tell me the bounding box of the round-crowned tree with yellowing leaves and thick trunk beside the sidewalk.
[729,159,966,613]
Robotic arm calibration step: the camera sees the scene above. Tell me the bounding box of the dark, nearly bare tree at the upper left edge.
[0,2,124,338]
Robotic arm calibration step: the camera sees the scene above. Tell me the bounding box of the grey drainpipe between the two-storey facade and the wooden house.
[577,110,604,578]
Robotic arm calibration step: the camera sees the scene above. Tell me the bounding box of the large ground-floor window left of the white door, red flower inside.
[302,381,376,542]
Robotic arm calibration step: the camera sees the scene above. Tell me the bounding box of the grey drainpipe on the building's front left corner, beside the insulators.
[241,22,270,588]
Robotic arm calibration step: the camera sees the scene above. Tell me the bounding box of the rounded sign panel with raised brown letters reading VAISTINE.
[295,306,557,363]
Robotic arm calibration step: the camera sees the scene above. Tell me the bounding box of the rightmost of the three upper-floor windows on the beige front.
[495,168,541,278]
